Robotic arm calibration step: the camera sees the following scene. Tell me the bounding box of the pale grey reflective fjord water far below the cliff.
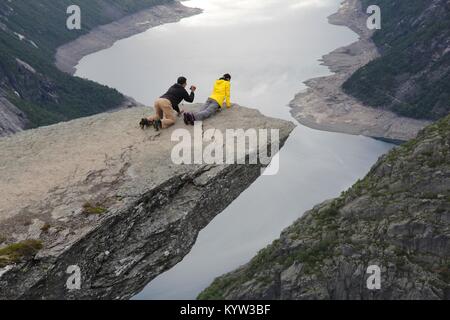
[77,0,392,299]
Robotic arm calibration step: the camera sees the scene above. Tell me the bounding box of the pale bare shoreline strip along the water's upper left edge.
[55,2,202,75]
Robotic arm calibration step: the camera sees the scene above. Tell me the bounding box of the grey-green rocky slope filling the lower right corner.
[199,116,450,299]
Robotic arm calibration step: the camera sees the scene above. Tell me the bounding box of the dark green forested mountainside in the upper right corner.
[343,0,450,120]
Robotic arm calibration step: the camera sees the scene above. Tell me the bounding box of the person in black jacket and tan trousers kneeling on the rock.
[140,77,197,130]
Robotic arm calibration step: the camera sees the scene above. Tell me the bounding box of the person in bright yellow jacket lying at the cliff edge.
[184,73,231,125]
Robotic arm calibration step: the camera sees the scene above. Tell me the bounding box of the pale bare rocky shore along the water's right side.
[290,0,430,141]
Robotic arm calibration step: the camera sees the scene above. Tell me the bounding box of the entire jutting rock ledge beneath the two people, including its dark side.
[0,106,293,299]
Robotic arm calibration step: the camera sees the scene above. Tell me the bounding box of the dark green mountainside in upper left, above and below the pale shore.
[0,0,173,136]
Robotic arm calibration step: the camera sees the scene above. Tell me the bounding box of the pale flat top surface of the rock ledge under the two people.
[0,105,294,298]
